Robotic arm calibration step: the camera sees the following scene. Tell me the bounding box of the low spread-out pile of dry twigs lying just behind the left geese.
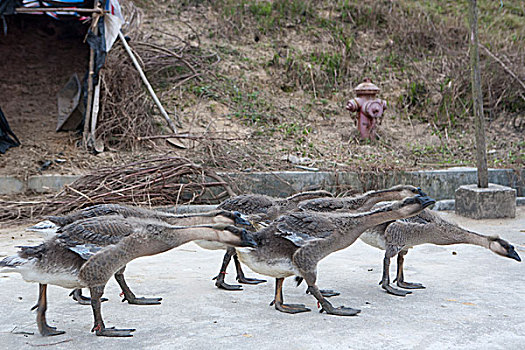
[0,157,235,221]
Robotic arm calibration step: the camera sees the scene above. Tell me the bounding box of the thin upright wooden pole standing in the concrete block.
[469,0,489,188]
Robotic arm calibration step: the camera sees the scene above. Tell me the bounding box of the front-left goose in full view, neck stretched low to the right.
[0,216,256,337]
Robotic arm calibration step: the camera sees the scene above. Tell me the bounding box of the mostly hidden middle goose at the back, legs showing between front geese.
[205,190,333,291]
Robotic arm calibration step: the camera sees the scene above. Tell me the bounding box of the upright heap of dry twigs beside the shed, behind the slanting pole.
[97,2,219,149]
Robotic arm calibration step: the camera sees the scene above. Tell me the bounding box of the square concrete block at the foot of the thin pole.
[456,184,516,219]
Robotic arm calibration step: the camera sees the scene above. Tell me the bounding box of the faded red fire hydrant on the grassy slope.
[346,78,386,139]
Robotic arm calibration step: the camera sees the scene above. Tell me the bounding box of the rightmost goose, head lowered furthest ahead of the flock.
[360,209,521,296]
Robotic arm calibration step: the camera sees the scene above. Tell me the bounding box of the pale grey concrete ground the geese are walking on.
[0,207,525,349]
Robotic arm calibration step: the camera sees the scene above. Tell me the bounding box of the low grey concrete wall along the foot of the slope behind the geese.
[0,168,525,200]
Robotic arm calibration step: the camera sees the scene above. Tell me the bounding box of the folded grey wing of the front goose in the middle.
[275,212,335,247]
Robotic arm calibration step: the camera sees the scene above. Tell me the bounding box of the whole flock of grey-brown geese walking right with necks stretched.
[0,185,521,337]
